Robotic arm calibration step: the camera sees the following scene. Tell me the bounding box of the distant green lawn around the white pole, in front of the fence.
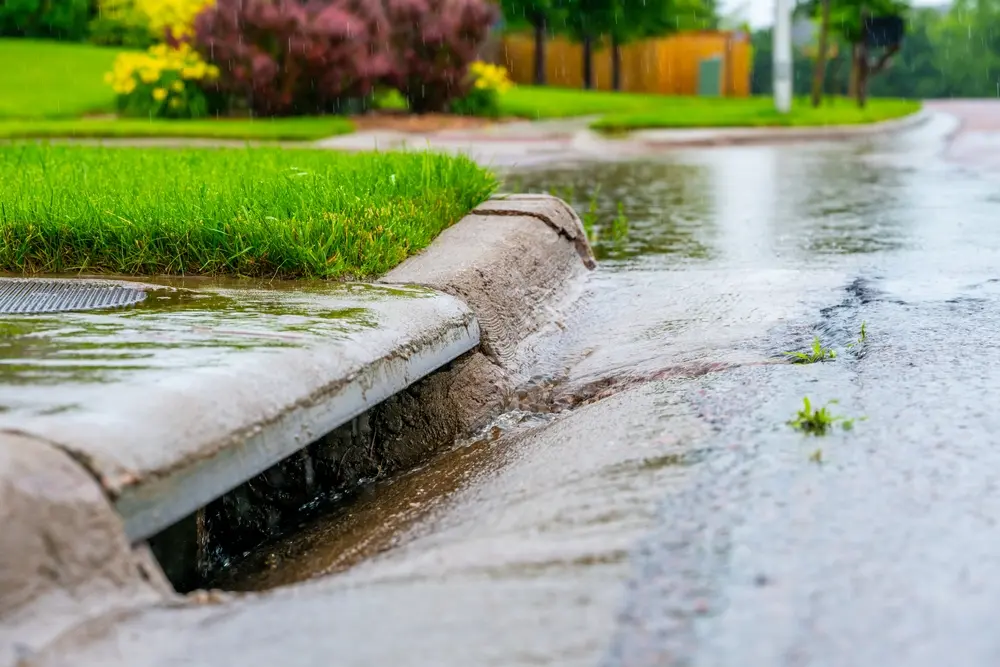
[501,86,920,131]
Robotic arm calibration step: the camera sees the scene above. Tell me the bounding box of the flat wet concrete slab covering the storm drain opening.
[0,283,479,540]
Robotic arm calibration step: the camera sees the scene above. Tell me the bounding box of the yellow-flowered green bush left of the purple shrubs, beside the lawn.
[104,43,219,118]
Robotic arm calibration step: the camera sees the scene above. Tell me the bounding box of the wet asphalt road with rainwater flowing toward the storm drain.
[35,104,1000,667]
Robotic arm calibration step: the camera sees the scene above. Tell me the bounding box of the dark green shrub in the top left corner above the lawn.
[0,0,90,41]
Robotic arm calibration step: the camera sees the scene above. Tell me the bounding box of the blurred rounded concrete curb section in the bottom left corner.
[0,432,172,665]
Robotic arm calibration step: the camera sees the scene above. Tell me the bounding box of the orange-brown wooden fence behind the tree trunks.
[499,31,751,97]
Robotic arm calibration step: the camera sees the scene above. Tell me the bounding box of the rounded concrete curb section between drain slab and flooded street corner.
[379,196,593,367]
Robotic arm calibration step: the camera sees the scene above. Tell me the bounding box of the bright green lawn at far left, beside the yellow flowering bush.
[0,39,120,118]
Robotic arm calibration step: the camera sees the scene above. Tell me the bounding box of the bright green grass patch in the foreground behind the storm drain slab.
[0,143,497,278]
